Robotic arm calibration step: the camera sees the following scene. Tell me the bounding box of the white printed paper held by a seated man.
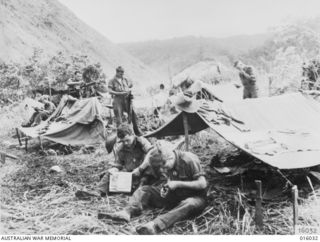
[109,172,132,193]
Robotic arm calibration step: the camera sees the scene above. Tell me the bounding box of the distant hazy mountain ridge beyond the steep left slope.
[120,33,272,78]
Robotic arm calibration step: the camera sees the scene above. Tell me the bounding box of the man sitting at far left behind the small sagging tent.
[22,95,56,127]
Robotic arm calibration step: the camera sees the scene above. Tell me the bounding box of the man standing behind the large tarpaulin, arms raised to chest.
[234,61,258,99]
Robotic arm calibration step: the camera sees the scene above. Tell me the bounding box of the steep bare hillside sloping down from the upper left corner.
[0,0,159,85]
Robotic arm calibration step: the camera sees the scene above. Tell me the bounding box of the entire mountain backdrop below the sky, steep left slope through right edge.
[0,0,320,92]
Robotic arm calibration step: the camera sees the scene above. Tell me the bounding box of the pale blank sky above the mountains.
[59,0,320,43]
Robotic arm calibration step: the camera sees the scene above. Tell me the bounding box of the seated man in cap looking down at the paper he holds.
[98,124,152,196]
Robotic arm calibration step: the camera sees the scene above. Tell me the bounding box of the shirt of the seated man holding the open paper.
[114,137,152,172]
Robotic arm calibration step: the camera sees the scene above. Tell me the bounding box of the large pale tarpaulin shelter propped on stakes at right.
[146,93,320,169]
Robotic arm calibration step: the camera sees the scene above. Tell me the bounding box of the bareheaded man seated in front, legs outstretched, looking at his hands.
[98,142,207,234]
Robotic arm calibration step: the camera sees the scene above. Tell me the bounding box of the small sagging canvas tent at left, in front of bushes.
[19,96,104,145]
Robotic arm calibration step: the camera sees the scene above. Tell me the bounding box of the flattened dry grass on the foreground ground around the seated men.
[0,123,320,235]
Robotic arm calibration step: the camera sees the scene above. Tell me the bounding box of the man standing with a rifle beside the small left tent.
[108,66,141,136]
